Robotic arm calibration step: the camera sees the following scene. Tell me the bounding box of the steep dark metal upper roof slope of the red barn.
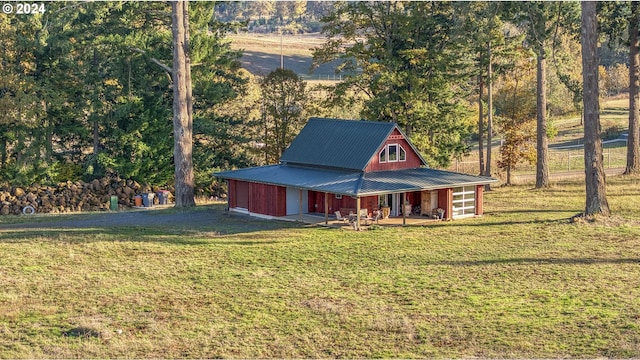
[280,118,402,171]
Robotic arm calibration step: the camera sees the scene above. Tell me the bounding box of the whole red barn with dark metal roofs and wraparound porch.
[215,118,497,228]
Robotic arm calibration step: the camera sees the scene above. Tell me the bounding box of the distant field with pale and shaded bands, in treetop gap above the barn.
[230,34,340,81]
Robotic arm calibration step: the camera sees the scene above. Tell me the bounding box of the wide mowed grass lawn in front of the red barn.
[0,177,640,358]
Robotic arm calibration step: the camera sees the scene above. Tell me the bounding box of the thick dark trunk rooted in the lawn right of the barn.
[581,1,609,216]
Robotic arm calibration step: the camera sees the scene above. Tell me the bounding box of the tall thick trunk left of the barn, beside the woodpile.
[171,1,195,207]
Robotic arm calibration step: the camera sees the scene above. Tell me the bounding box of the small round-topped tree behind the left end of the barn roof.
[260,69,308,164]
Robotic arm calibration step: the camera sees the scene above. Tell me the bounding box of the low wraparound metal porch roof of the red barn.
[214,164,497,197]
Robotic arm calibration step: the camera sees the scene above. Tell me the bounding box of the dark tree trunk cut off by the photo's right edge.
[624,1,640,174]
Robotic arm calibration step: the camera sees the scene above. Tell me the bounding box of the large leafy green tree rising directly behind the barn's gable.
[314,1,473,166]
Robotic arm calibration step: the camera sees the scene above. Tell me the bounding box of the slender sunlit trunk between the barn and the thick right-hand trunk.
[536,43,550,189]
